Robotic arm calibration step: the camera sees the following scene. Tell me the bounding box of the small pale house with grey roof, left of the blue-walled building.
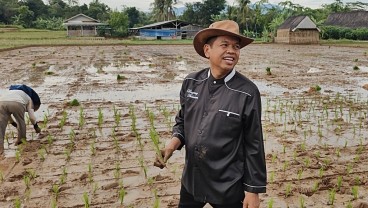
[63,14,107,37]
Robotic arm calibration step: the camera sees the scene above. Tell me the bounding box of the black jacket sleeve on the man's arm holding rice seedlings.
[172,81,185,150]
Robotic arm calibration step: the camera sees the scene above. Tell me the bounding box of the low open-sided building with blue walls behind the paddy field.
[129,20,203,40]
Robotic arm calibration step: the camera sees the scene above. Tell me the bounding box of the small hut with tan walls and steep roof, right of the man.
[275,16,320,44]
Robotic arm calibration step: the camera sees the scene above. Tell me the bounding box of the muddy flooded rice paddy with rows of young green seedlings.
[0,44,368,208]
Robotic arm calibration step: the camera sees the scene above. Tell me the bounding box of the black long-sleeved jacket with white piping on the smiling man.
[173,68,267,204]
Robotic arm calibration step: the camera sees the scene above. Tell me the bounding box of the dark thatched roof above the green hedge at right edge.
[325,10,368,29]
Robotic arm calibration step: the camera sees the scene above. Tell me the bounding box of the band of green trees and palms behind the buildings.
[0,0,368,38]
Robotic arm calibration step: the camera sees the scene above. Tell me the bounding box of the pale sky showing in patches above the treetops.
[68,0,350,12]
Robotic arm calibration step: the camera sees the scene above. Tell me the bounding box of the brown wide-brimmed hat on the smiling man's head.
[193,20,253,58]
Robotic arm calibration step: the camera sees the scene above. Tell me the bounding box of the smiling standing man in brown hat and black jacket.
[155,20,267,208]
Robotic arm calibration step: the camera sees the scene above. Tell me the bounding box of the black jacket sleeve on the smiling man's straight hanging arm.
[243,90,267,193]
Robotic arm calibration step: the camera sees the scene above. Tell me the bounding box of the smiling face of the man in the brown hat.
[204,36,240,75]
